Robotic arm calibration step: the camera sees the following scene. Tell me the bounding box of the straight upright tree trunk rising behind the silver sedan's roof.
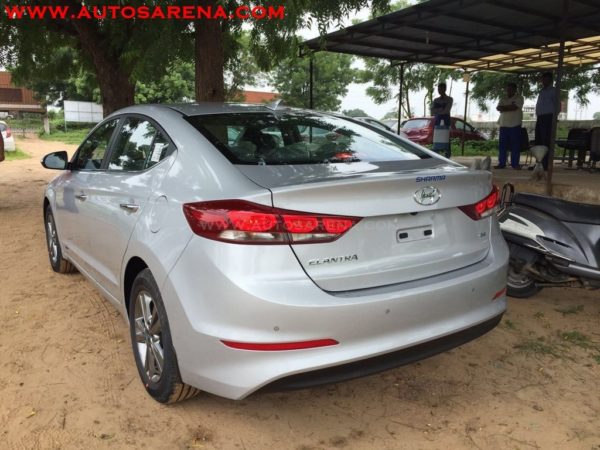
[194,0,225,102]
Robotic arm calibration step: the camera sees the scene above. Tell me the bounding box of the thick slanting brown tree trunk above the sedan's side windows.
[73,20,135,116]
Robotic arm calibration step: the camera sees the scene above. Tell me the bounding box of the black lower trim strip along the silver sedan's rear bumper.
[260,314,503,392]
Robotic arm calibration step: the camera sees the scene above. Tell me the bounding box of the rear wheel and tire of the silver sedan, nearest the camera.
[129,269,200,403]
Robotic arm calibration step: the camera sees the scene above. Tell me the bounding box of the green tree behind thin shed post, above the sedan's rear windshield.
[271,53,357,111]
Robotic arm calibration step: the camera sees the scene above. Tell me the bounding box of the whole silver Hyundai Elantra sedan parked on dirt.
[42,104,508,403]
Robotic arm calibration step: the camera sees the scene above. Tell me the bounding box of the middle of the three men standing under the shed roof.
[494,83,523,170]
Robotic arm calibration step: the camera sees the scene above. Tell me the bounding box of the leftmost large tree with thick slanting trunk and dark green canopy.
[0,0,185,113]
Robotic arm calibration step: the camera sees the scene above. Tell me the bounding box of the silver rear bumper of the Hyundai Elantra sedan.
[161,225,508,399]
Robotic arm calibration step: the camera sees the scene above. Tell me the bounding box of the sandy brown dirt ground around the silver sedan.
[0,139,600,450]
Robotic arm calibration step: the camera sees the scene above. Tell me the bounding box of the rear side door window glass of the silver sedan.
[108,117,162,172]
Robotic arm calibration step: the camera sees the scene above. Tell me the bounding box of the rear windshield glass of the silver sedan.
[187,111,431,165]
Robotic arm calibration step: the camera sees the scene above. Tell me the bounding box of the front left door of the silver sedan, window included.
[54,119,118,275]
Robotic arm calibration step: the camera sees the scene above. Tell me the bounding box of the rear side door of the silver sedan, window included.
[88,116,174,299]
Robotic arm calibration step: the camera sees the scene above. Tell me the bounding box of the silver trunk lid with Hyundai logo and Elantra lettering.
[239,162,491,291]
